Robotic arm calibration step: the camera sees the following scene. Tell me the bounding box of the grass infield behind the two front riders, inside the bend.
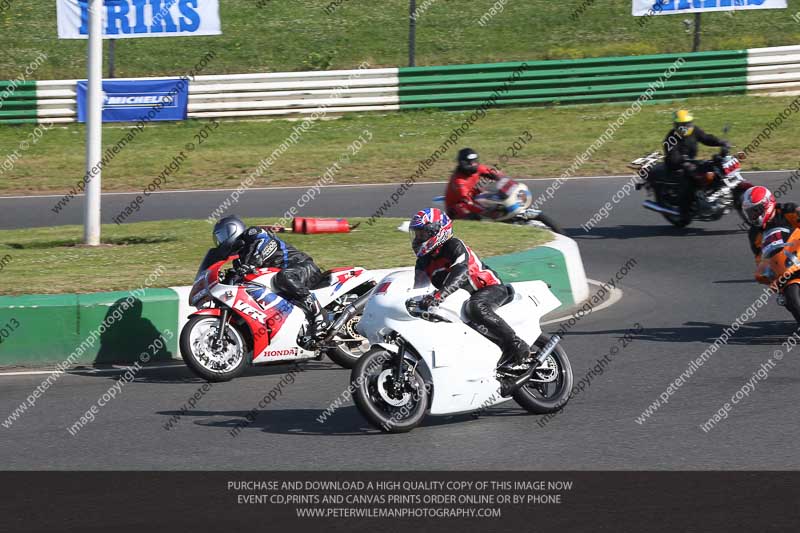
[0,218,551,295]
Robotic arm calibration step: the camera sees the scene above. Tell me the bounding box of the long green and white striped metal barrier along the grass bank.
[0,46,800,124]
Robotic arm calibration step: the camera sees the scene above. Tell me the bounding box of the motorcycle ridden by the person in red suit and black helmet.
[433,177,564,235]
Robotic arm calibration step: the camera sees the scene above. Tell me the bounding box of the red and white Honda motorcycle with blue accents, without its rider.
[180,249,375,381]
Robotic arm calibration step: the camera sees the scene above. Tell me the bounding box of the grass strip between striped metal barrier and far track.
[0,92,800,194]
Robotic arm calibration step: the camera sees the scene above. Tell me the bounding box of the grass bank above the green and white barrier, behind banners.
[0,0,800,79]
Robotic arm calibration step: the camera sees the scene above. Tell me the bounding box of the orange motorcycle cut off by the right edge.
[755,227,800,325]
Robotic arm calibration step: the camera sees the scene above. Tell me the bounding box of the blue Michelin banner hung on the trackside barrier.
[78,78,189,122]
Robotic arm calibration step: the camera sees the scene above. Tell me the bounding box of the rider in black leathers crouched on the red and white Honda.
[214,216,330,337]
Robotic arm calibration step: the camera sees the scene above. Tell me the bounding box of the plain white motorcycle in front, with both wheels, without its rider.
[351,271,572,433]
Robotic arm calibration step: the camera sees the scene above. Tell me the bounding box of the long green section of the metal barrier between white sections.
[399,50,747,109]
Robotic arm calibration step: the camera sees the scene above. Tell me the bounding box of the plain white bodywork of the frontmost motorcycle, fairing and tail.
[358,271,561,415]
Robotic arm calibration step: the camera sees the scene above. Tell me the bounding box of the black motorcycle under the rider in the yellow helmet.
[629,147,752,228]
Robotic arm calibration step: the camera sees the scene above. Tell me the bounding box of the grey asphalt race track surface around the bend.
[0,173,800,470]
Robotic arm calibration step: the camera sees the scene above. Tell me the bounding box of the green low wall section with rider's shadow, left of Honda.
[0,289,179,366]
